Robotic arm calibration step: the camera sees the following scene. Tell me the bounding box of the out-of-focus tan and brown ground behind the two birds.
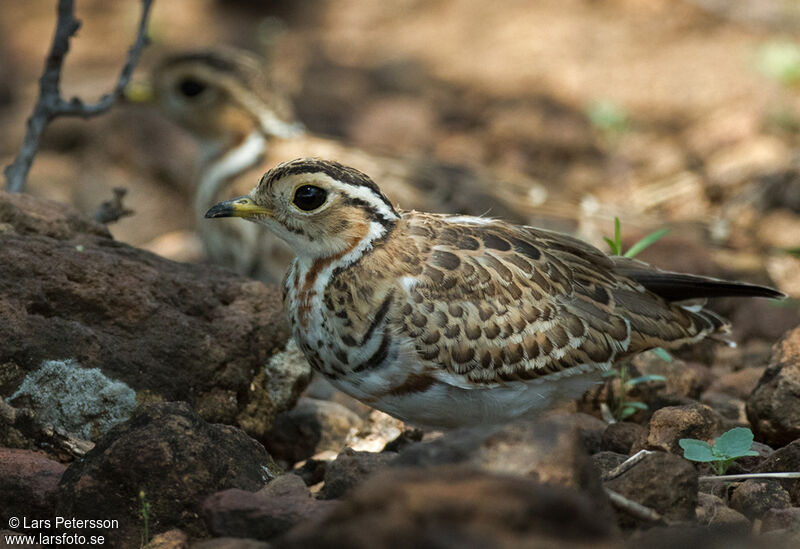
[0,0,800,312]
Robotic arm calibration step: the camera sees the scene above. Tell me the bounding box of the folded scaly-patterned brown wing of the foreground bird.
[401,213,722,386]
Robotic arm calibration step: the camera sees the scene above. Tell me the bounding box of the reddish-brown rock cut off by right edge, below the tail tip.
[747,327,800,446]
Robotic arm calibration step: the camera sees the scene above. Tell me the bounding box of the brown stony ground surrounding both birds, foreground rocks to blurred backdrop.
[0,0,800,548]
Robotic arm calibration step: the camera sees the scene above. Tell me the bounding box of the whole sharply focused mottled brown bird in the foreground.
[206,159,781,426]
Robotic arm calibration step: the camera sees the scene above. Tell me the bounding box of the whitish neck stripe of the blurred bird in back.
[194,130,267,217]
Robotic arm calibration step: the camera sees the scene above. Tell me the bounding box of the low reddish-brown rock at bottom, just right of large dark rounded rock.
[203,474,337,540]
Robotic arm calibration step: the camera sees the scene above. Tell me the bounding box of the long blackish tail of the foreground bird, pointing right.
[613,257,786,301]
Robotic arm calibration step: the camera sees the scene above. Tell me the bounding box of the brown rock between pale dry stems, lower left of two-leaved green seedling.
[605,452,697,527]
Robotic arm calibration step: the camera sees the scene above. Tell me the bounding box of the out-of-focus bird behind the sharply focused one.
[128,48,539,282]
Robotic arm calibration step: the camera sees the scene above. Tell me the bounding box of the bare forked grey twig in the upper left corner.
[5,0,153,192]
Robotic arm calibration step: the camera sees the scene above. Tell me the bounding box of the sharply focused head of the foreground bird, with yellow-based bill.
[205,159,399,258]
